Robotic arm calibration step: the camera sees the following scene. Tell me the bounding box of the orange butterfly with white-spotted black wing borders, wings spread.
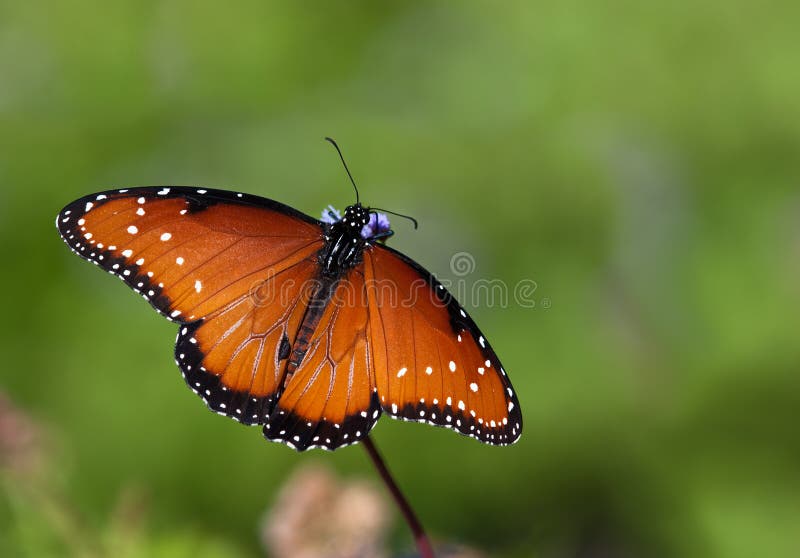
[56,154,522,451]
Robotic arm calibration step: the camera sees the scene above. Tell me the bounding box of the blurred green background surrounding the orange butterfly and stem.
[0,0,800,558]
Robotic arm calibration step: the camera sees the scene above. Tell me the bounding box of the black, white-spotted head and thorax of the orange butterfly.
[319,203,370,277]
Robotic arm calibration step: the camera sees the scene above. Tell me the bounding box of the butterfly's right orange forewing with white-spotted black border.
[364,245,522,445]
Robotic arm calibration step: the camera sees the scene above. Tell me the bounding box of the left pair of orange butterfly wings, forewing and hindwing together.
[57,187,324,424]
